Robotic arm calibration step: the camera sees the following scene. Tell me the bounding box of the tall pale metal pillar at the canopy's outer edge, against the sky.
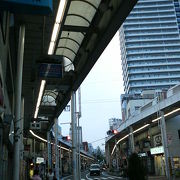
[71,91,77,180]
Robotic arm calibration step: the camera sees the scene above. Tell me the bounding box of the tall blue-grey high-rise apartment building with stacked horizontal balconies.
[120,0,180,94]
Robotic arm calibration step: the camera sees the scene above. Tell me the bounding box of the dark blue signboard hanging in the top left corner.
[0,0,52,15]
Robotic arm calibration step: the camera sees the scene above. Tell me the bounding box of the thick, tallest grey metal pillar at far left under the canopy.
[13,25,25,180]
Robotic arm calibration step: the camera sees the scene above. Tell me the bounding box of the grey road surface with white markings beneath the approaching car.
[63,171,124,180]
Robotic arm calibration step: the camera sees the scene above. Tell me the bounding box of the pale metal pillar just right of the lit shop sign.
[161,111,170,179]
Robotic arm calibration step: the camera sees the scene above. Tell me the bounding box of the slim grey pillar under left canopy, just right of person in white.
[55,118,59,180]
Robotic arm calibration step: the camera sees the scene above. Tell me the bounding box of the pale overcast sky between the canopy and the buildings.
[59,33,123,149]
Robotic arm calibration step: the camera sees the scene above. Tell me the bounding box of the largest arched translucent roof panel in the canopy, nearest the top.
[55,0,101,66]
